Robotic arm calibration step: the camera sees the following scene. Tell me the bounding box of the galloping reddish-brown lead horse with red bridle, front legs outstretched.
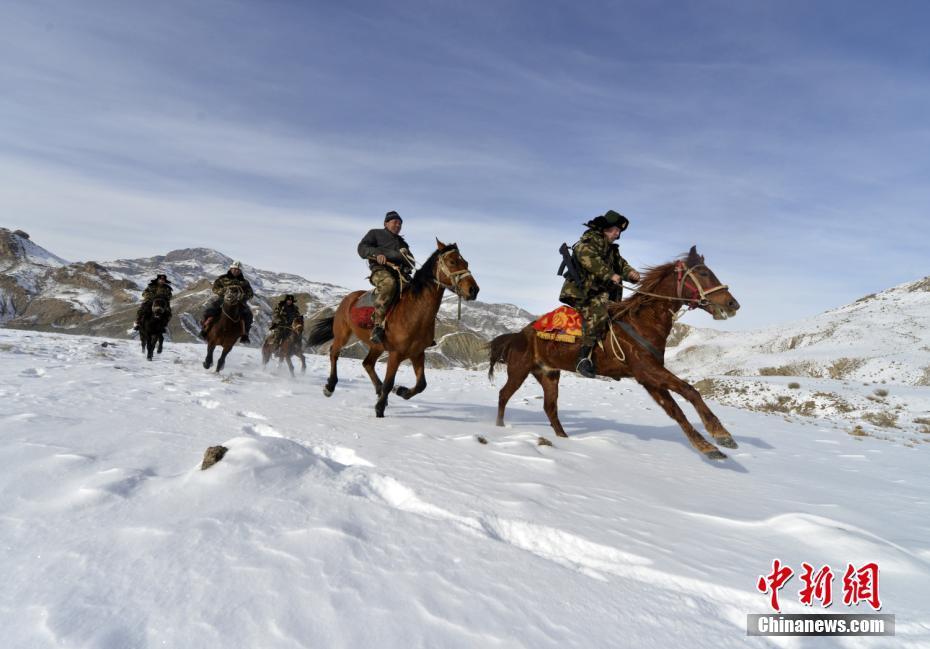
[488,247,739,460]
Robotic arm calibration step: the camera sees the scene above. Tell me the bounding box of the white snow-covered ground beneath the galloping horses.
[0,330,930,649]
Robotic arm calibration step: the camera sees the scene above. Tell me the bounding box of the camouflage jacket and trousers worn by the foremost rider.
[559,228,635,347]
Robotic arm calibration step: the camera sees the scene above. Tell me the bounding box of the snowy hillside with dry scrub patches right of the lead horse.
[668,278,930,443]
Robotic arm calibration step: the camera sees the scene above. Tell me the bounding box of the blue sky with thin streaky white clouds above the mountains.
[0,0,930,328]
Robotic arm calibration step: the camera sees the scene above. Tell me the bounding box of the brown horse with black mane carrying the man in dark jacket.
[308,239,478,417]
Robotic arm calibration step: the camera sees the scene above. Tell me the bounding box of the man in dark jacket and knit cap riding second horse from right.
[358,210,415,343]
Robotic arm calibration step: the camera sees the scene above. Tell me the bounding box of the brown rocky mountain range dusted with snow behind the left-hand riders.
[0,228,533,367]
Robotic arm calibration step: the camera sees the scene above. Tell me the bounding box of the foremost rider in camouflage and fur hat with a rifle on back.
[559,210,640,378]
